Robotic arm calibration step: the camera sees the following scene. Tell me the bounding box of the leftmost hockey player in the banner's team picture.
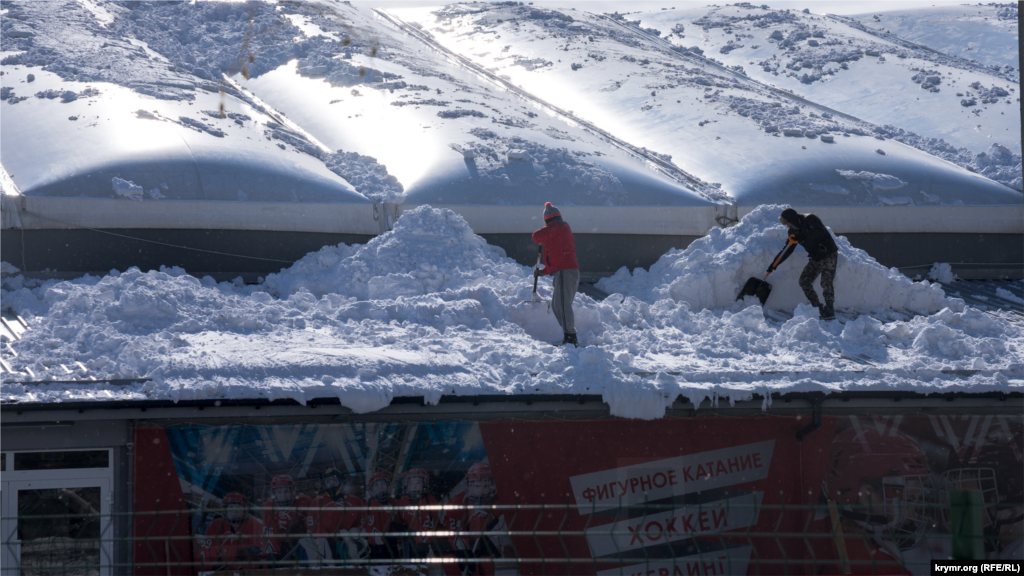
[201,492,263,570]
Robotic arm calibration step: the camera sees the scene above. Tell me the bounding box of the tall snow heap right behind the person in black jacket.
[597,205,955,314]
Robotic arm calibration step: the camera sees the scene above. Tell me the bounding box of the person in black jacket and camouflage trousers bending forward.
[768,208,839,320]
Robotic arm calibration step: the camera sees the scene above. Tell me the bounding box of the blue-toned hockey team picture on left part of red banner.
[140,416,515,576]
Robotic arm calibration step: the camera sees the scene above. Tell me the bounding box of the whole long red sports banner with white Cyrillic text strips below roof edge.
[135,414,1024,576]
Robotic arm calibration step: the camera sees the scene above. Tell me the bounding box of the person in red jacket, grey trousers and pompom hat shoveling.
[534,202,580,346]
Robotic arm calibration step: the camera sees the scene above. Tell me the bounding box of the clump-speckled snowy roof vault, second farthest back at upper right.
[631,4,1021,156]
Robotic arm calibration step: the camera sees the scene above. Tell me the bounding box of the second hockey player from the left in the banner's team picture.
[263,475,316,561]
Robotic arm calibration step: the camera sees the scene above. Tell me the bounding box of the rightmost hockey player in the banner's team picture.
[444,462,519,576]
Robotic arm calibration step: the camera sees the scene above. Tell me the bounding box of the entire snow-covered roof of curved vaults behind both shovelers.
[6,0,1021,235]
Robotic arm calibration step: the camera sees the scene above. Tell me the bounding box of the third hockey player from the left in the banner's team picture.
[316,468,369,560]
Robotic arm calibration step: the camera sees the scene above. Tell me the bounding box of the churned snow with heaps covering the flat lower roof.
[0,206,1024,418]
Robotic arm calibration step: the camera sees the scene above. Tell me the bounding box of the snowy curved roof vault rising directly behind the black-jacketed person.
[393,4,1020,217]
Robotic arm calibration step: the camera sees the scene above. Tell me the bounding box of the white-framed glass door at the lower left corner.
[3,479,112,576]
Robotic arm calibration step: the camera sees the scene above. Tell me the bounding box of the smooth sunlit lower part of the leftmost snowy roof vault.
[0,67,369,203]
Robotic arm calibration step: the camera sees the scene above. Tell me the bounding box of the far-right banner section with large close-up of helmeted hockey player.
[811,414,1024,576]
